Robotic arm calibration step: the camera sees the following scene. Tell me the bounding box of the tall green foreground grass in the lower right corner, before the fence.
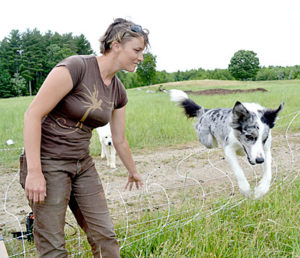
[122,180,300,257]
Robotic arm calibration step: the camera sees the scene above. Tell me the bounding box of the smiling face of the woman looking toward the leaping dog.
[119,37,145,72]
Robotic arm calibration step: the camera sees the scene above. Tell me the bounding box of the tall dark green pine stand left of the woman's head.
[0,29,94,98]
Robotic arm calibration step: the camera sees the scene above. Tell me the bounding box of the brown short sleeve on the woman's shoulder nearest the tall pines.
[56,55,85,87]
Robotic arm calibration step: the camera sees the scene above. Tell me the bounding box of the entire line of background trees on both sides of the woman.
[0,29,300,98]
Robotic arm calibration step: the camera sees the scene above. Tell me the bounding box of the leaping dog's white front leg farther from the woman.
[254,148,272,199]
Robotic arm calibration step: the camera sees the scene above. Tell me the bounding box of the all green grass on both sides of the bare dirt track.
[0,81,300,257]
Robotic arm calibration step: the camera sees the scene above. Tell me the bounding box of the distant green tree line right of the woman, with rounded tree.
[130,50,300,88]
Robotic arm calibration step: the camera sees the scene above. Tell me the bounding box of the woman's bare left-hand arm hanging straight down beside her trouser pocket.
[24,67,73,203]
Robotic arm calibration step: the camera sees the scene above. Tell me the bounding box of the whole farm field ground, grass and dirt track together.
[0,80,300,257]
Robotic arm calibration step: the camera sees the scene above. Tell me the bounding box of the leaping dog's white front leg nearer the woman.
[224,146,251,198]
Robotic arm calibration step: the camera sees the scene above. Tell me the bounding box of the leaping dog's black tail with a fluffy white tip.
[170,89,205,118]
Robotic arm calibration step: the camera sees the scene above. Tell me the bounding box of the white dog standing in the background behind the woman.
[96,123,116,168]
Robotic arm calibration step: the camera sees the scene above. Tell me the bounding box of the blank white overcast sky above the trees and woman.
[0,0,300,72]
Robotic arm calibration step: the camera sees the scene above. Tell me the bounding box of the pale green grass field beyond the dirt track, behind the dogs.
[0,81,300,157]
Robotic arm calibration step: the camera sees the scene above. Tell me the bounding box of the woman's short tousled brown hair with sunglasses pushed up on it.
[99,18,149,54]
